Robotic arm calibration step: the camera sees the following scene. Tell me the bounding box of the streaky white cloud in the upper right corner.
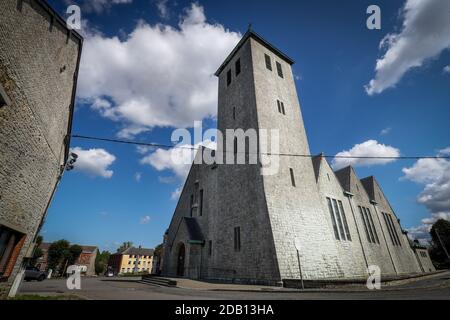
[365,0,450,95]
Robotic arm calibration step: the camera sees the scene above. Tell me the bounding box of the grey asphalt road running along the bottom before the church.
[19,273,450,300]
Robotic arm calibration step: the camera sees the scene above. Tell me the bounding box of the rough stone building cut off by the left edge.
[0,0,83,297]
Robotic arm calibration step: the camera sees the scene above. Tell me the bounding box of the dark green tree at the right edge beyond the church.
[430,219,450,269]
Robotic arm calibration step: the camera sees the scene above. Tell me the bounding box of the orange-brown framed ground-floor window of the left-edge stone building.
[0,226,25,279]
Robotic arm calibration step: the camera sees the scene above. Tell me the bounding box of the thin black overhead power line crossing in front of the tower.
[71,134,450,160]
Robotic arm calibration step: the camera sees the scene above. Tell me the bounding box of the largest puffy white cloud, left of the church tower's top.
[78,4,241,137]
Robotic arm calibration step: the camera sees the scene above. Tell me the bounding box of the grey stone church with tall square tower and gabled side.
[162,30,428,285]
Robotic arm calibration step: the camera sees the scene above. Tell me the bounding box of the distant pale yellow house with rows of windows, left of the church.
[108,247,154,274]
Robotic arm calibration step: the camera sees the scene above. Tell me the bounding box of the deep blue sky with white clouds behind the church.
[43,0,450,250]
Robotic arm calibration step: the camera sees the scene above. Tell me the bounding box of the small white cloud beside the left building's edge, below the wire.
[71,147,116,178]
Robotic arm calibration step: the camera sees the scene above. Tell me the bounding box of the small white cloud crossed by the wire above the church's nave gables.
[332,140,400,169]
